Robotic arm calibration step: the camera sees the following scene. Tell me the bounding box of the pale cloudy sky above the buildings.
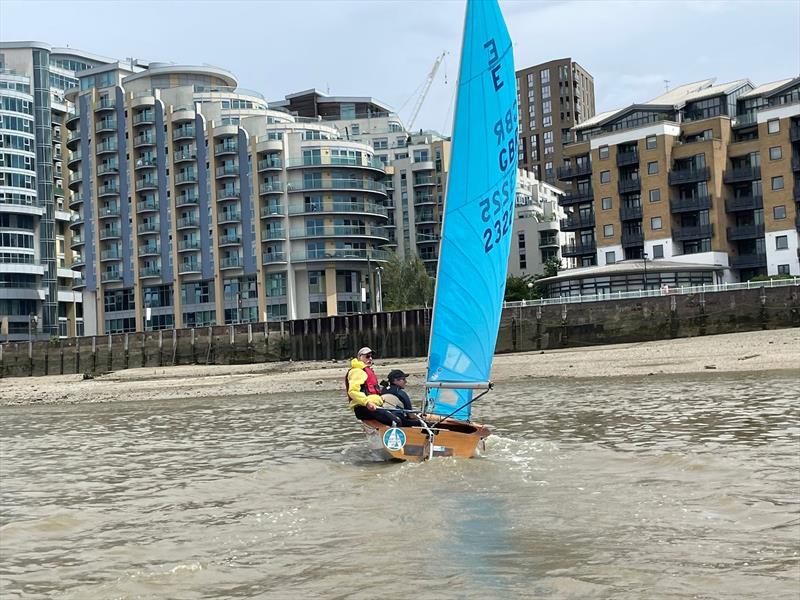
[0,0,800,133]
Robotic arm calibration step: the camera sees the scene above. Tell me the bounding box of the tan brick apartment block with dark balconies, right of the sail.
[558,78,800,281]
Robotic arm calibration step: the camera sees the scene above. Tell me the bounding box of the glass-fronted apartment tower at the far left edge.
[0,42,115,341]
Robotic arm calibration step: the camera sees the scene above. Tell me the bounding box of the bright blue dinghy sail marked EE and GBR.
[426,0,518,420]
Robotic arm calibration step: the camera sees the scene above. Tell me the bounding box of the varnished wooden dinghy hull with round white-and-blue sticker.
[361,419,490,462]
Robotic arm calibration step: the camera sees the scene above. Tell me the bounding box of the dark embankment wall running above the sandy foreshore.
[0,286,800,377]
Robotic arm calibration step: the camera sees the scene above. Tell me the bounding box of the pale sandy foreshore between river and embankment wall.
[0,329,800,406]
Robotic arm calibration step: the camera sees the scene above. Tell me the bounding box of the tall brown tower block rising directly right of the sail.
[517,58,595,186]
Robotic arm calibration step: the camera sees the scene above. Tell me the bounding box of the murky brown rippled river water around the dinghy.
[0,374,800,600]
